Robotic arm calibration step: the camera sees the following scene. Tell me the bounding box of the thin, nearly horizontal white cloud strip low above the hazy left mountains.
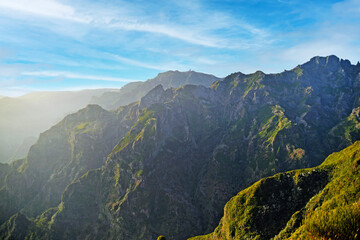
[22,71,139,82]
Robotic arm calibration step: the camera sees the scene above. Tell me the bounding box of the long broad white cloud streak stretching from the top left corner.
[0,0,267,49]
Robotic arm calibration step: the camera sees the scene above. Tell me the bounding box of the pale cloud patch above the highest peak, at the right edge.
[278,0,360,64]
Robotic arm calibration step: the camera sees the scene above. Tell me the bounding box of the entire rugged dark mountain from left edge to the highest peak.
[0,56,360,240]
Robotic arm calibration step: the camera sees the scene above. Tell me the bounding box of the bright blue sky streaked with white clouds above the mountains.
[0,0,360,96]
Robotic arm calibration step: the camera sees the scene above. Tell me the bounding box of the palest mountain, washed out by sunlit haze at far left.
[0,89,109,162]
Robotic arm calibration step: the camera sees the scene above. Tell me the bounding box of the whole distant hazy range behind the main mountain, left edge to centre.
[0,71,219,162]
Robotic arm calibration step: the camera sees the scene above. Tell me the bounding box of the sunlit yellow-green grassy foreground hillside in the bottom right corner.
[191,142,360,240]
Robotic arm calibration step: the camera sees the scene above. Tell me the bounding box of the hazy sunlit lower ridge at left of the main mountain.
[0,105,139,221]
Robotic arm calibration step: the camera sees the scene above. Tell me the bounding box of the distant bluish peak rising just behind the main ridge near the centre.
[91,71,220,109]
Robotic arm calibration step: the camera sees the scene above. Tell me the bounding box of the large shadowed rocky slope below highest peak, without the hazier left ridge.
[0,56,360,240]
